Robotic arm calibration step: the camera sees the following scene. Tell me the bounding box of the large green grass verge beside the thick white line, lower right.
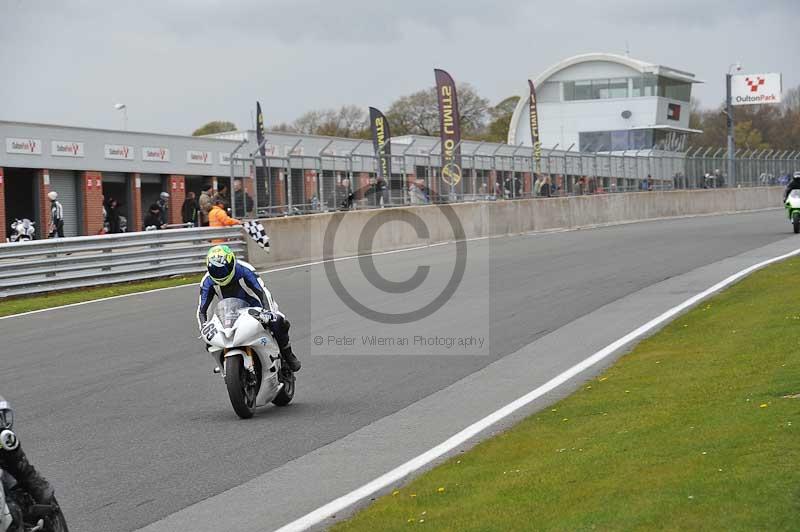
[333,259,800,532]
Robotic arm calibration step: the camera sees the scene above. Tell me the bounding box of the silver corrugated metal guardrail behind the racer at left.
[0,227,247,298]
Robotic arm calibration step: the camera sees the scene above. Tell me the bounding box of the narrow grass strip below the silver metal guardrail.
[0,274,201,316]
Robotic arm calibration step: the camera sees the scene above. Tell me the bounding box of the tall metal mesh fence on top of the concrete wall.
[231,141,800,218]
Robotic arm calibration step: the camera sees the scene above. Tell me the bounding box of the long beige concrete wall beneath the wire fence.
[248,187,783,268]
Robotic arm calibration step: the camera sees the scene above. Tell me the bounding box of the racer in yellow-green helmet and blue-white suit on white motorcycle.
[197,245,301,372]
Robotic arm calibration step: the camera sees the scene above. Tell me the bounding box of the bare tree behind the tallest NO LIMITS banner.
[386,83,489,139]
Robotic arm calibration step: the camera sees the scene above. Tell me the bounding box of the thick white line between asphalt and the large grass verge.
[276,245,800,532]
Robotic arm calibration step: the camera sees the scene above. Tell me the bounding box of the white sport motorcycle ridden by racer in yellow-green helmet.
[200,298,295,419]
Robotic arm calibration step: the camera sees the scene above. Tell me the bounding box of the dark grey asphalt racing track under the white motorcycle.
[0,211,790,531]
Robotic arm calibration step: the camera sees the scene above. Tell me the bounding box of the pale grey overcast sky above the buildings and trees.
[0,0,800,134]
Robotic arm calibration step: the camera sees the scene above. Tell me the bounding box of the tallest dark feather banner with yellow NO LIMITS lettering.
[434,68,461,187]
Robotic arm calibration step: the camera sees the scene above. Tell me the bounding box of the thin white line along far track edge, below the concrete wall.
[0,207,777,321]
